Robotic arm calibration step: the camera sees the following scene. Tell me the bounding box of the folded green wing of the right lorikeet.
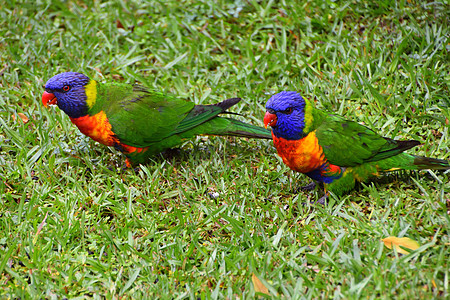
[316,115,420,167]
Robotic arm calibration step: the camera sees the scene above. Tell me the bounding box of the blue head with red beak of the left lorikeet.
[42,72,91,118]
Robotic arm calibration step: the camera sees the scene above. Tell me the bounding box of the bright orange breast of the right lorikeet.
[272,131,326,173]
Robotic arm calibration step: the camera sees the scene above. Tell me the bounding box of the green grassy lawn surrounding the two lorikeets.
[0,0,450,299]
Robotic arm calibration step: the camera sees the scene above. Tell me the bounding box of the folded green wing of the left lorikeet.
[97,83,222,147]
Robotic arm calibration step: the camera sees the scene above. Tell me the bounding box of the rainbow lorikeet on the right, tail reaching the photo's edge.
[264,92,450,203]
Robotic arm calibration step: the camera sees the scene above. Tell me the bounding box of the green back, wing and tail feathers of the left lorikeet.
[89,83,271,152]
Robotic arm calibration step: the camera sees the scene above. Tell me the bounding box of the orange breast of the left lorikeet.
[70,111,119,146]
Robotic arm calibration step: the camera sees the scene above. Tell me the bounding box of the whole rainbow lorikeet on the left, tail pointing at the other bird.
[42,72,272,166]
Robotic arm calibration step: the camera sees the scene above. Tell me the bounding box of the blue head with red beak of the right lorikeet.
[264,91,307,140]
